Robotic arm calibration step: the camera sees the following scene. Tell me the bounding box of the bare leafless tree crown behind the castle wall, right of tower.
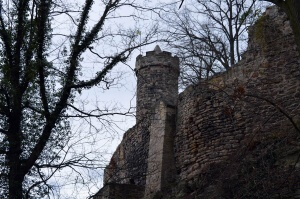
[163,0,260,85]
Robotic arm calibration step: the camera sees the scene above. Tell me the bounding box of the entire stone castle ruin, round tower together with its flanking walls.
[99,7,300,198]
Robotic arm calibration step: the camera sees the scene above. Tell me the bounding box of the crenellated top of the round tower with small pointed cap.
[135,45,179,74]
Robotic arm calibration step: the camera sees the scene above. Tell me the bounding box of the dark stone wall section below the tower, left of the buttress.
[104,123,149,185]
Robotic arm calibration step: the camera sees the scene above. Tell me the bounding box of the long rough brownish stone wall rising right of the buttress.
[175,7,300,181]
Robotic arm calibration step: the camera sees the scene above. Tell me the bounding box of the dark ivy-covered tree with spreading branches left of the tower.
[0,0,155,199]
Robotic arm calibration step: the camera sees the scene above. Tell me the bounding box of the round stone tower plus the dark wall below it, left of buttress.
[104,46,179,185]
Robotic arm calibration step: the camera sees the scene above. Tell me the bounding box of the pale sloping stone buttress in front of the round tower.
[145,102,176,198]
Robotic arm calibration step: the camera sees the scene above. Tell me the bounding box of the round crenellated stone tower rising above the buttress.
[135,45,179,122]
